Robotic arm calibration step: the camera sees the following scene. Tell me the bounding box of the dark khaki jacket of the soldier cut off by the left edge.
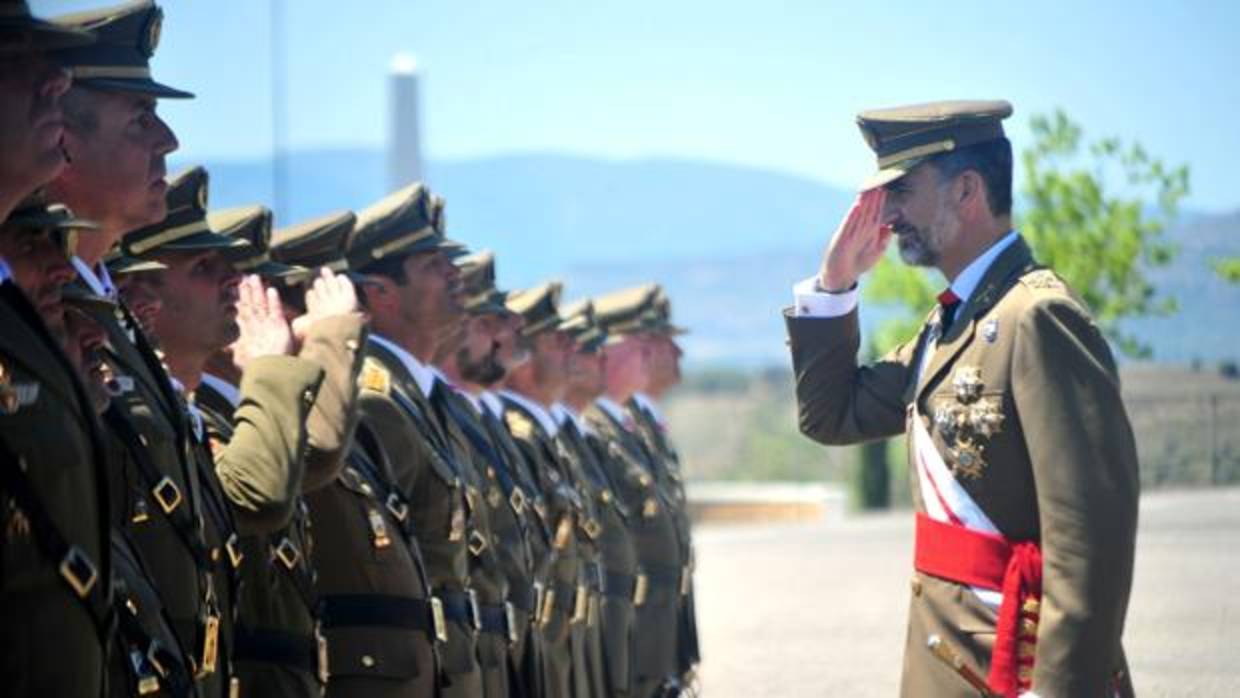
[0,281,112,698]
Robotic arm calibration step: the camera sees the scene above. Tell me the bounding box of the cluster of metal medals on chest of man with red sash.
[934,366,1003,480]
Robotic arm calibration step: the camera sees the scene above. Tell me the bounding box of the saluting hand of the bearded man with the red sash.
[818,187,892,293]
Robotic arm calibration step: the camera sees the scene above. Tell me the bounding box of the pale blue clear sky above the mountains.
[31,0,1240,211]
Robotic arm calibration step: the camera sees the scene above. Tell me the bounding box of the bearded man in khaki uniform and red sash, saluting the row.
[786,102,1138,698]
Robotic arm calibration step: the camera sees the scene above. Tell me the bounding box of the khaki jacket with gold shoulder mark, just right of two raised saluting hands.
[358,340,482,697]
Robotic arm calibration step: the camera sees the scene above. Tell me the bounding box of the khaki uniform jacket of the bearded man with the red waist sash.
[787,241,1138,698]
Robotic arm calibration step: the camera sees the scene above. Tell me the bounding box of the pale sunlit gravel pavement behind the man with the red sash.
[694,488,1240,698]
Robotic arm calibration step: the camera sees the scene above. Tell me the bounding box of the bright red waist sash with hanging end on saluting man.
[913,513,1042,697]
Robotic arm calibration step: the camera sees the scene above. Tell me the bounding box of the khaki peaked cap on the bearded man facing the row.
[857,100,1012,190]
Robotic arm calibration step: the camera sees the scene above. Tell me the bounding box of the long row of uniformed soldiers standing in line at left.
[0,0,699,698]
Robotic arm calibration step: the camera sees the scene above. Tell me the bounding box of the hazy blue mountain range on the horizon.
[181,150,1240,366]
